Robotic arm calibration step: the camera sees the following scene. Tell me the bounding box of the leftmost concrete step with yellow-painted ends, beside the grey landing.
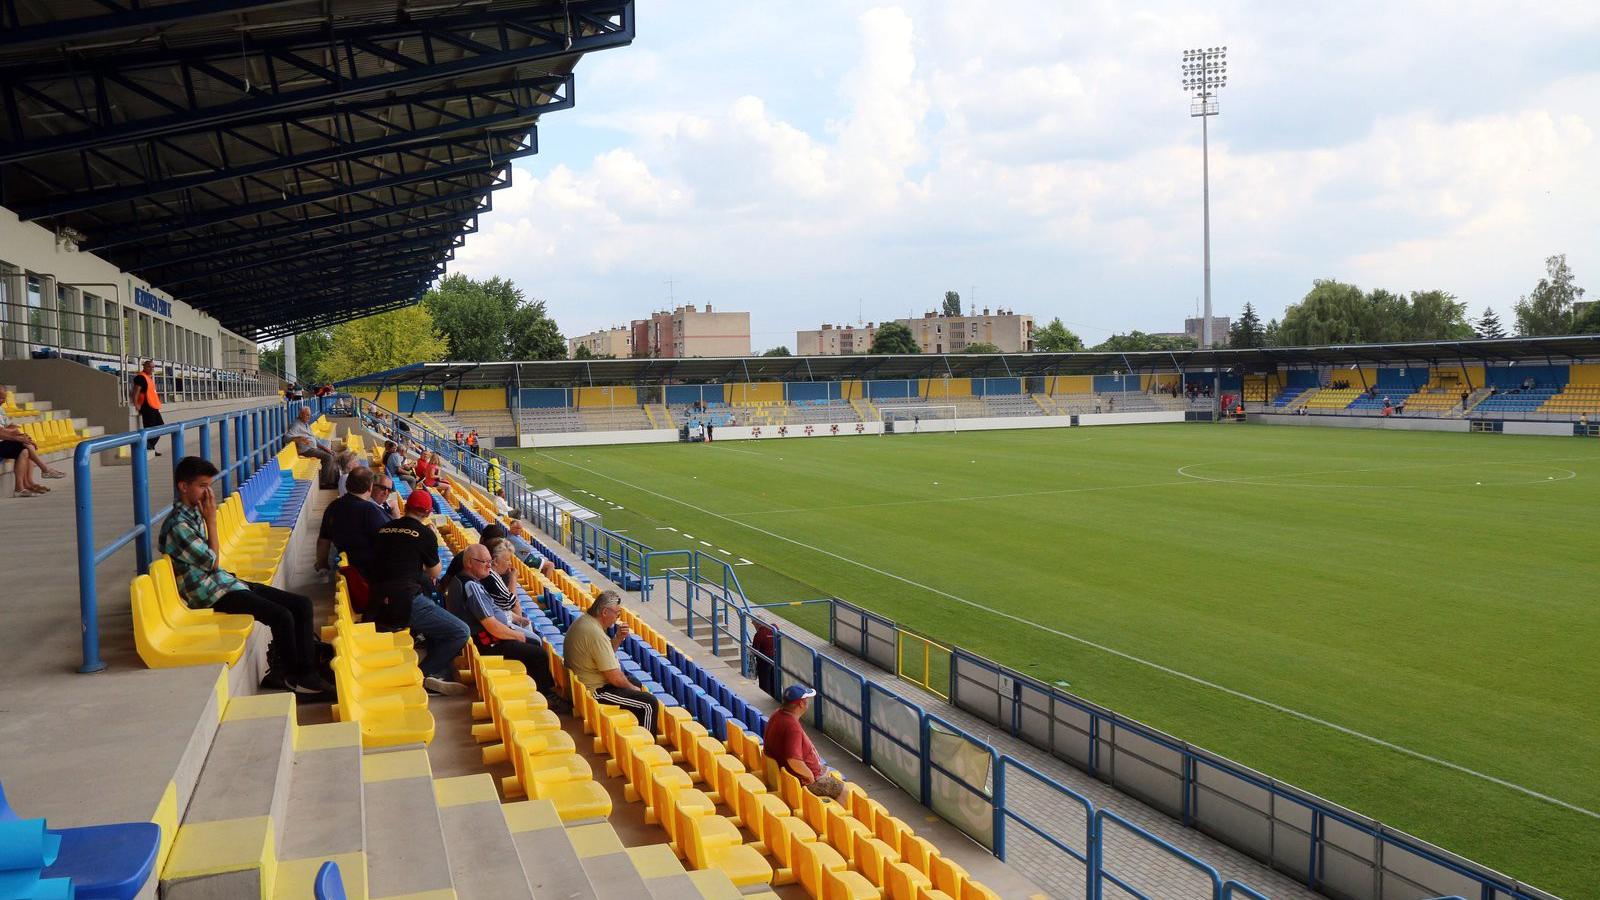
[162,693,294,900]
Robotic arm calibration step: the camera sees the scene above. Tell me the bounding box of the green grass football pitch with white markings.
[505,424,1600,897]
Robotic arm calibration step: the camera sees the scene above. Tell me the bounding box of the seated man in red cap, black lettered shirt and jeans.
[366,488,469,693]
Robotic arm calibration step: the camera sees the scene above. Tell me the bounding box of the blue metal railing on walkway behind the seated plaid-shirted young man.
[72,399,325,673]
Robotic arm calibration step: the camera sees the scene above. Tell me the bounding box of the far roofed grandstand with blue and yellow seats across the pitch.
[339,336,1600,447]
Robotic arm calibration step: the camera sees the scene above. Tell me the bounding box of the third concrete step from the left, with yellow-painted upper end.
[362,749,451,900]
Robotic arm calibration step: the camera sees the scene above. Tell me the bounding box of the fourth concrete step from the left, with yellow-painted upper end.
[434,772,542,900]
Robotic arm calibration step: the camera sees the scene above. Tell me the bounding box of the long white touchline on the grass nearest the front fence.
[534,456,1600,818]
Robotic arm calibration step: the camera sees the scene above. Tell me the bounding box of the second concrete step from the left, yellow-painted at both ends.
[275,722,366,900]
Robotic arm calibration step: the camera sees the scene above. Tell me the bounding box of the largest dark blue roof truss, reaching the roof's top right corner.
[0,0,634,163]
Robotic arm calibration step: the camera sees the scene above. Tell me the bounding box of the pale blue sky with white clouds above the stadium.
[454,0,1600,351]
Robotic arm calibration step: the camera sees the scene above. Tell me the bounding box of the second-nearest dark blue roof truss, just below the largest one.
[10,75,573,221]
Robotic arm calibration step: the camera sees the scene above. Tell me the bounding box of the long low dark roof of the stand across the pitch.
[339,335,1600,388]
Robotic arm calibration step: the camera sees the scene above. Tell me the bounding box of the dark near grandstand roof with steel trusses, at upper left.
[0,0,634,338]
